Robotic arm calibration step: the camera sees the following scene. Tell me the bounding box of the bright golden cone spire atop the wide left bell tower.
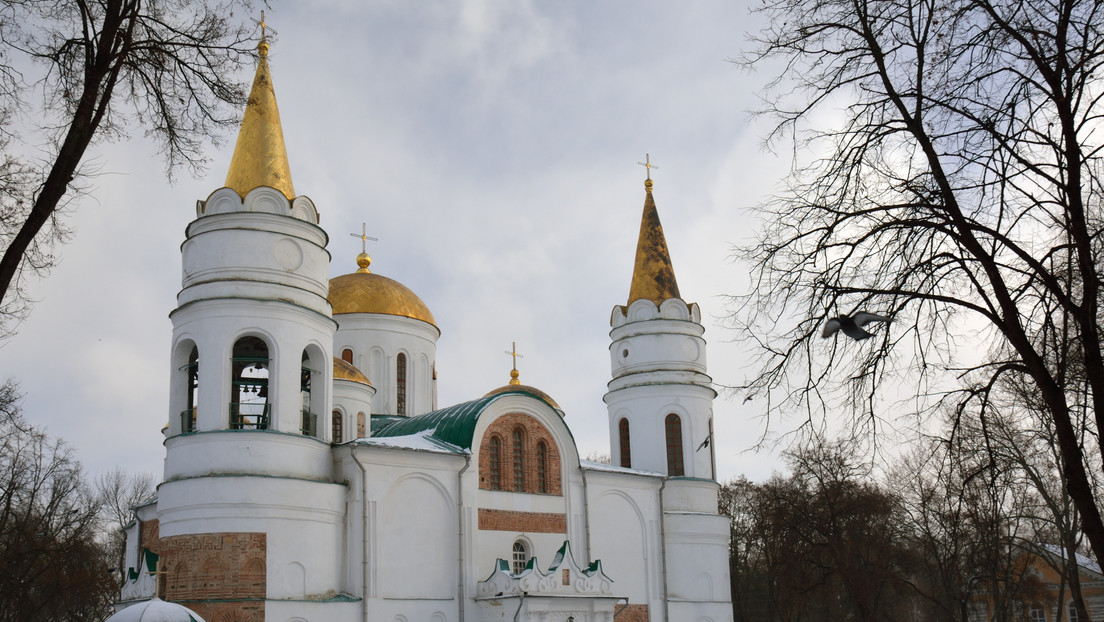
[226,13,295,200]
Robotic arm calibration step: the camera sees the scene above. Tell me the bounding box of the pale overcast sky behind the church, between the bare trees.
[0,0,788,479]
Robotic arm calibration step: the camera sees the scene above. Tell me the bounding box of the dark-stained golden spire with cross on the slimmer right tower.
[626,158,681,306]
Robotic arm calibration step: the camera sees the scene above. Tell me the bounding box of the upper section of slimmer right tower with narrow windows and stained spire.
[604,172,716,479]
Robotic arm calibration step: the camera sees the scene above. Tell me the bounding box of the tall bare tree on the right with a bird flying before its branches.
[737,0,1104,559]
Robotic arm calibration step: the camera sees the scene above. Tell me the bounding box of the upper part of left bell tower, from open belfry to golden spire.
[167,31,337,464]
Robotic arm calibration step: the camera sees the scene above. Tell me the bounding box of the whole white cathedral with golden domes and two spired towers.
[113,32,732,622]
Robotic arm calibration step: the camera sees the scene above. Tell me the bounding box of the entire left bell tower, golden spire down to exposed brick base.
[151,30,348,620]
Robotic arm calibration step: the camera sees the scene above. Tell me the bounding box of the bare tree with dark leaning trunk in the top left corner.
[0,0,257,334]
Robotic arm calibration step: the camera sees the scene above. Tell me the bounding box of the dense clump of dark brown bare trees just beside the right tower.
[721,442,914,622]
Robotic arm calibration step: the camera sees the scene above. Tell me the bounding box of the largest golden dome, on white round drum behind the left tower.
[329,271,437,327]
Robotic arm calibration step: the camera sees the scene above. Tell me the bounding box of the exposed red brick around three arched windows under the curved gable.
[479,412,563,495]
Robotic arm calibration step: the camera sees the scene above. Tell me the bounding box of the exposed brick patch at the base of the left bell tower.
[159,534,267,622]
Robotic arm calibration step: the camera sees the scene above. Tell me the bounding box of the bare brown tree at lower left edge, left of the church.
[0,382,118,622]
